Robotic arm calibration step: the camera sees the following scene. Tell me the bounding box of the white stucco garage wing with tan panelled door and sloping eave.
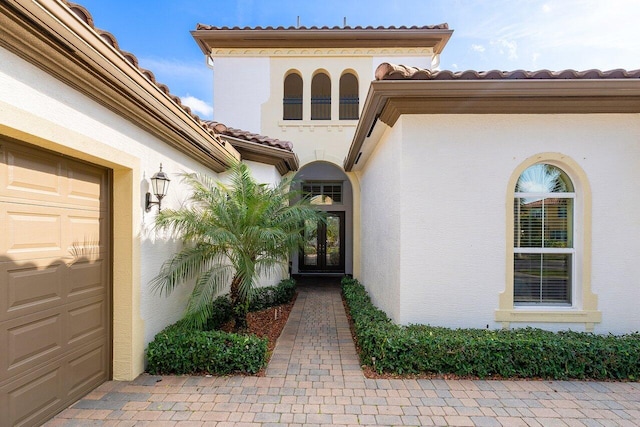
[0,0,298,425]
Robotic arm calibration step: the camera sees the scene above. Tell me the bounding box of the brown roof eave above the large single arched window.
[344,79,640,171]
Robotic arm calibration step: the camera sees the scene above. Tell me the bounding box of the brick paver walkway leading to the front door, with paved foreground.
[46,284,640,427]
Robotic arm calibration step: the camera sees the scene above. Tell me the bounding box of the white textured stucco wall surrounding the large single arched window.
[362,114,640,333]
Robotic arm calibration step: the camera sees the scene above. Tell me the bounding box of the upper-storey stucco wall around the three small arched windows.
[213,49,432,167]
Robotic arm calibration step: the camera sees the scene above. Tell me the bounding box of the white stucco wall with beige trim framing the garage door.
[0,48,276,379]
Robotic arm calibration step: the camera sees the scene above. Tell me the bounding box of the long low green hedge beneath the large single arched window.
[342,278,640,381]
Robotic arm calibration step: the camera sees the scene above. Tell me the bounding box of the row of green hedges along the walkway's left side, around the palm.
[147,279,296,375]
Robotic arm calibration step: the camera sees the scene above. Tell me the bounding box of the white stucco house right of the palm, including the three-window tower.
[192,24,640,340]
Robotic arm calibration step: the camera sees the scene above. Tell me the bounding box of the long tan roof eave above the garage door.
[0,0,239,172]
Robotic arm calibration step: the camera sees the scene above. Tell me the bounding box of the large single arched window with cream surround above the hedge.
[495,152,602,331]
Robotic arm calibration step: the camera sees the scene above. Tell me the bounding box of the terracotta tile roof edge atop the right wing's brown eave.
[375,62,640,80]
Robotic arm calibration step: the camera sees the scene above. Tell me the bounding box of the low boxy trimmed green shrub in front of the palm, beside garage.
[147,325,267,375]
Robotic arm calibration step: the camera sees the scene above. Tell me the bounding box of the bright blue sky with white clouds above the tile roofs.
[75,0,640,118]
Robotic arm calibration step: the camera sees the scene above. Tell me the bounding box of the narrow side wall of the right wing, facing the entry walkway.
[359,125,402,322]
